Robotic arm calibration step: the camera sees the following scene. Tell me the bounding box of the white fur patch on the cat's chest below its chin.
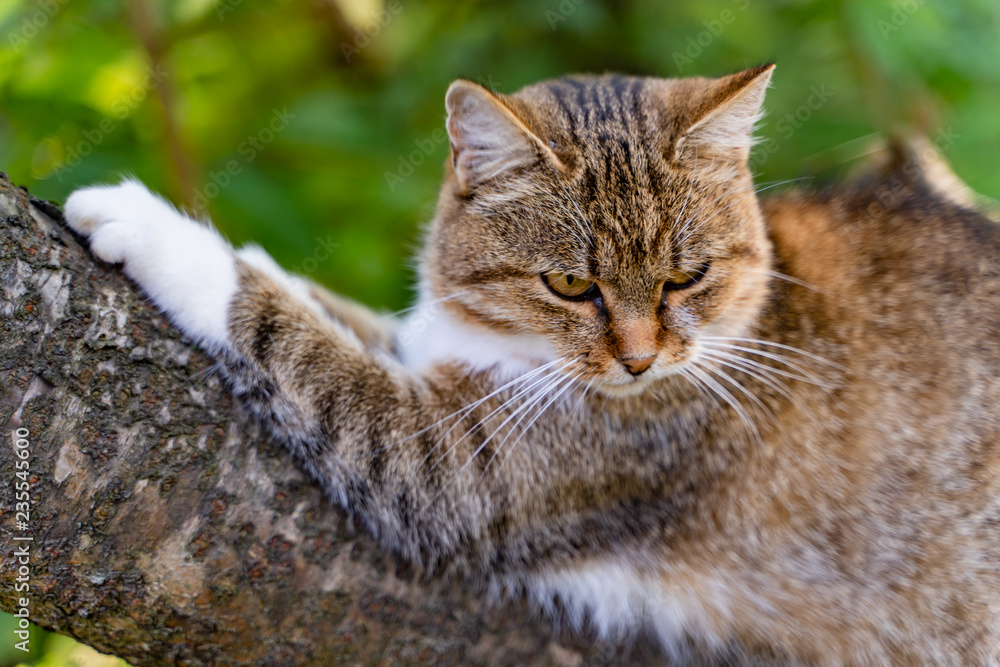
[396,296,558,375]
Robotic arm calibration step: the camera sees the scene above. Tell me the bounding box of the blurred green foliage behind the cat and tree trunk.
[0,0,1000,667]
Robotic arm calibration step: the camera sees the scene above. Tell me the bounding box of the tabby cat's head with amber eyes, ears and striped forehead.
[423,65,773,395]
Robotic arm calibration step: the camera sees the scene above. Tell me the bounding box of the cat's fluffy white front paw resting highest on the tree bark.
[65,181,237,347]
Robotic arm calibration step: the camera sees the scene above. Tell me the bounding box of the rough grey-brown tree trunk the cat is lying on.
[0,174,659,665]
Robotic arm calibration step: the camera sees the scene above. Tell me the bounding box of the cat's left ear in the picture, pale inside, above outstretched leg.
[445,79,560,192]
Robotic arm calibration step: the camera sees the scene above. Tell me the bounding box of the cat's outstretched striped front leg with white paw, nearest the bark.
[65,181,492,560]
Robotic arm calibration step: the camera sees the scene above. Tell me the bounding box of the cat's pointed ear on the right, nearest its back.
[672,63,774,167]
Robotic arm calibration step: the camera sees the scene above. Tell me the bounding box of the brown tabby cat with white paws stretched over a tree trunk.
[66,65,1000,665]
